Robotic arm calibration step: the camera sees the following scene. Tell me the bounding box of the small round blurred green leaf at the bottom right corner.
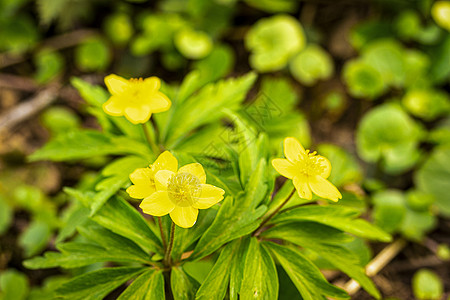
[412,269,444,300]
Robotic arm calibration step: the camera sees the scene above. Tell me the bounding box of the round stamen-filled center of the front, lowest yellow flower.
[167,173,202,207]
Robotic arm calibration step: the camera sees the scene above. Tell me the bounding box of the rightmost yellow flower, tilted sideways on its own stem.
[272,137,342,201]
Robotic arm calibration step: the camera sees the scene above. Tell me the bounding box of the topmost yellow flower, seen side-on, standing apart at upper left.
[103,74,172,124]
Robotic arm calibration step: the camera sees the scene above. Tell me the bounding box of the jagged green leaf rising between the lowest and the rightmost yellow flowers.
[191,160,267,259]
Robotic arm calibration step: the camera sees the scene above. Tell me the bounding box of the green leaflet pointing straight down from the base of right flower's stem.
[240,238,278,300]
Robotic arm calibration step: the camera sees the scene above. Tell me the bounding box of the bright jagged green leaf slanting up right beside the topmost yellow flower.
[166,73,256,148]
